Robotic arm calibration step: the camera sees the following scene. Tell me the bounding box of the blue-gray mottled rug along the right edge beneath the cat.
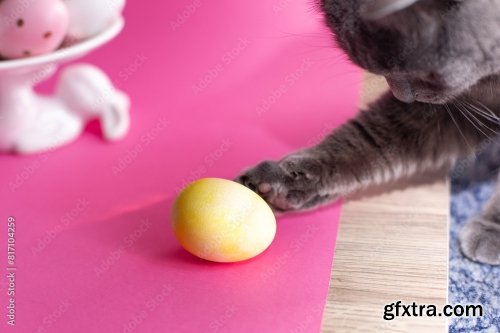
[449,143,500,333]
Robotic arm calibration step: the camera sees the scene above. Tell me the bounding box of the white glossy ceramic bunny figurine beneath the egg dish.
[0,65,129,154]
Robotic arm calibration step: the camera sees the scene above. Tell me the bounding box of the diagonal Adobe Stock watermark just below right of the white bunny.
[111,117,170,176]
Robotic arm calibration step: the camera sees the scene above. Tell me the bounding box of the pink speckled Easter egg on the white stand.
[0,0,69,59]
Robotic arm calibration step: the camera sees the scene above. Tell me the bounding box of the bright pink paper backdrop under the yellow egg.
[0,0,359,333]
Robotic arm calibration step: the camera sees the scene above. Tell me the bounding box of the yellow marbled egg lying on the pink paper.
[173,178,276,262]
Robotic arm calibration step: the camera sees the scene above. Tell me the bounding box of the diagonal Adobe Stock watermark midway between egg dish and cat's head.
[192,37,251,96]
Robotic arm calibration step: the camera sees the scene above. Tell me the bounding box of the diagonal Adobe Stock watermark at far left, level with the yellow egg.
[31,198,90,256]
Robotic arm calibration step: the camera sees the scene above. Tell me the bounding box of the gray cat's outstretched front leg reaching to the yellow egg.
[237,95,486,211]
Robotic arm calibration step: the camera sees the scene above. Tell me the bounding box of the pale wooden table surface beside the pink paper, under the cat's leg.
[322,75,450,333]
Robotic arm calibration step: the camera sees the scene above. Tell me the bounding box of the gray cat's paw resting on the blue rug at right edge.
[460,217,500,265]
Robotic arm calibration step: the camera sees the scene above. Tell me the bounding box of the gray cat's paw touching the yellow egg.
[236,154,335,212]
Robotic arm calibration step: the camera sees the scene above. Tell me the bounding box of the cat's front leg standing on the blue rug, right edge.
[460,174,500,265]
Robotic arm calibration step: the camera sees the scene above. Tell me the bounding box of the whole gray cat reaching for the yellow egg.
[237,0,500,265]
